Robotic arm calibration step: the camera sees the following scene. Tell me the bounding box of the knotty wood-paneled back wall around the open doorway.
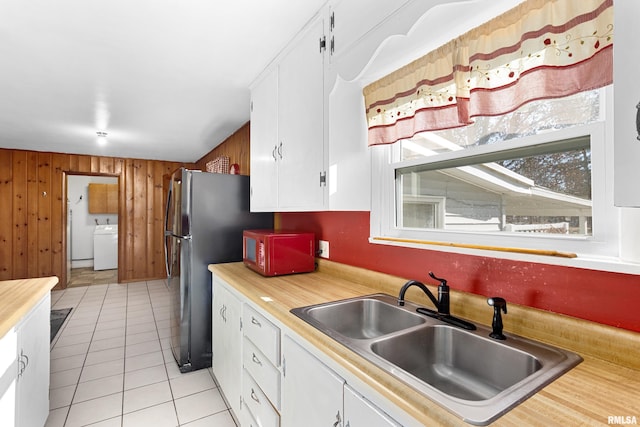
[0,149,190,288]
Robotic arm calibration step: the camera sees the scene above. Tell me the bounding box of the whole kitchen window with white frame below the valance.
[371,87,619,257]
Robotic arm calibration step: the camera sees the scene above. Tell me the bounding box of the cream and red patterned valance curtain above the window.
[364,0,613,145]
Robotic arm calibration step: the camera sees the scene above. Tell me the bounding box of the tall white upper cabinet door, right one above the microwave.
[278,14,326,211]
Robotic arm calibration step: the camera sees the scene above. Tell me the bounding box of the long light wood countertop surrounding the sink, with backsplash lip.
[209,260,640,427]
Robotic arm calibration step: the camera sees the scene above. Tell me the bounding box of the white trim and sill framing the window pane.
[369,87,640,274]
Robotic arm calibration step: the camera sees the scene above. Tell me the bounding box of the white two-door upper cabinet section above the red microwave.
[251,15,326,211]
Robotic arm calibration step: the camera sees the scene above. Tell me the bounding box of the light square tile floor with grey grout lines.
[46,280,236,427]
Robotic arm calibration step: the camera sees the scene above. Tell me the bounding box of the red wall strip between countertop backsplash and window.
[279,212,640,332]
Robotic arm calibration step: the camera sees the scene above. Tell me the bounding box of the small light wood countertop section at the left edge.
[0,276,58,338]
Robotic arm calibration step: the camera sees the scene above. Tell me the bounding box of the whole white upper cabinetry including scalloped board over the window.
[251,0,544,212]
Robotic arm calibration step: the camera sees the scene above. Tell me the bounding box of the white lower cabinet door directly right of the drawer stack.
[282,336,344,427]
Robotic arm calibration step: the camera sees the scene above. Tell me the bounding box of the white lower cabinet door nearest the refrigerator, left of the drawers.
[211,276,242,414]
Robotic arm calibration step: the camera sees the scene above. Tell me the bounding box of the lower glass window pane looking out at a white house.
[396,145,592,236]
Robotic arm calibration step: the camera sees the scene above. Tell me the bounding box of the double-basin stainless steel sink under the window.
[291,294,582,425]
